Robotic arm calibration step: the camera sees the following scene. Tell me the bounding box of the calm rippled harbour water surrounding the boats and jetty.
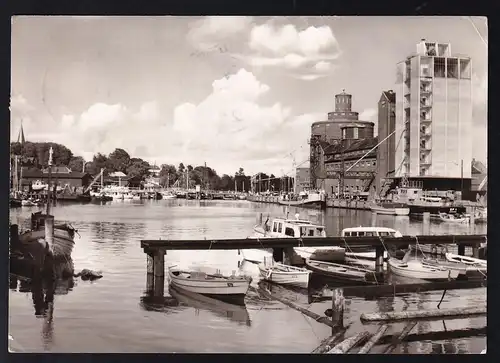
[9,199,486,354]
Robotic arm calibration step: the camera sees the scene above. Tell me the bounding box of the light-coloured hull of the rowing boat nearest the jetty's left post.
[169,270,254,298]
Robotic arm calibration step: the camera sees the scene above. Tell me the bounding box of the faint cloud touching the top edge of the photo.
[187,16,253,51]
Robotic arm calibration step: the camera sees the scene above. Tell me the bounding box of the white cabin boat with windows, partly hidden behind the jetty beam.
[241,213,345,263]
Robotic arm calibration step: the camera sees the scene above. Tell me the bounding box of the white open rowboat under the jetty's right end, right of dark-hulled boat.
[387,257,460,281]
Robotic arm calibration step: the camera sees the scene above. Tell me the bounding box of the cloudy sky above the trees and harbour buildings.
[10,16,488,175]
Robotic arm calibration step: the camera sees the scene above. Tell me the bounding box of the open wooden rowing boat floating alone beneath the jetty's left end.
[168,267,252,298]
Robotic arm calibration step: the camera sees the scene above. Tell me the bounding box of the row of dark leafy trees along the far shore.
[10,141,288,191]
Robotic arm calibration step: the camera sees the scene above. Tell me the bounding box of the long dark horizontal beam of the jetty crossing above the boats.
[141,235,486,253]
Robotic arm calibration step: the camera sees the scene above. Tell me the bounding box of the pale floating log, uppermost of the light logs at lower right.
[360,306,487,323]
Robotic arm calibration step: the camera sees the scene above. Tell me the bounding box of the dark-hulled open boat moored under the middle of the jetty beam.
[306,259,383,285]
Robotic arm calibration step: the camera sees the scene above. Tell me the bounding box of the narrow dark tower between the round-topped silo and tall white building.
[375,90,397,194]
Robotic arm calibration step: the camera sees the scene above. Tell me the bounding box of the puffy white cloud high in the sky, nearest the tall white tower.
[246,23,340,80]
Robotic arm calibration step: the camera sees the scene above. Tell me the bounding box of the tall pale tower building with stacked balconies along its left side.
[395,39,472,185]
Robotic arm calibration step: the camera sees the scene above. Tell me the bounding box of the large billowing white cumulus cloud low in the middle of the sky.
[173,69,319,173]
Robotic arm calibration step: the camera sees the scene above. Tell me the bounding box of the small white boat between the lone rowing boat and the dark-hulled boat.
[258,258,312,288]
